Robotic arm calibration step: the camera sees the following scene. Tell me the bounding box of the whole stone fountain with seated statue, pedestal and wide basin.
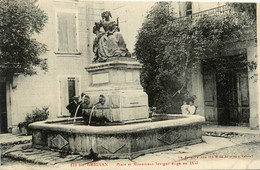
[29,12,205,159]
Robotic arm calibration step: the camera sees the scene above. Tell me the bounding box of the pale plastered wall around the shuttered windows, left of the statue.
[7,0,103,127]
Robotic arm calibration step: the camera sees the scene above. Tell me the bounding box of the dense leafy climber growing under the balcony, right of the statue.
[135,2,252,112]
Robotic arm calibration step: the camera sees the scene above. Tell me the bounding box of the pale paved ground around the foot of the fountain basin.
[1,131,260,170]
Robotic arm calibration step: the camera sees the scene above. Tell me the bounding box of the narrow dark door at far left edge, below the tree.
[0,82,8,133]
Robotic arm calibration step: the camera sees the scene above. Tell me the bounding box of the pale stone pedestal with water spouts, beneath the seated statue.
[83,57,149,122]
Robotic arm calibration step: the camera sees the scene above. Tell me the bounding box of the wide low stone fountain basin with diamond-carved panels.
[29,114,205,159]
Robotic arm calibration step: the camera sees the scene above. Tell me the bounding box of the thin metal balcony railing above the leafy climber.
[177,5,231,20]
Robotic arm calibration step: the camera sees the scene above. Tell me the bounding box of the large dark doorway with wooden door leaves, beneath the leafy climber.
[203,55,250,126]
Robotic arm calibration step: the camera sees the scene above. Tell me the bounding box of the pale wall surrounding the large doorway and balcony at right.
[177,2,260,129]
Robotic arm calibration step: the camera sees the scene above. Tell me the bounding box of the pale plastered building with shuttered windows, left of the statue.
[0,0,104,133]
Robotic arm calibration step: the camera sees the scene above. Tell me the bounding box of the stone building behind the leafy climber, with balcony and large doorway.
[172,2,259,129]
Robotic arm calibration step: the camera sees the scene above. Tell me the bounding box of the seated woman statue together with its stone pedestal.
[83,11,149,122]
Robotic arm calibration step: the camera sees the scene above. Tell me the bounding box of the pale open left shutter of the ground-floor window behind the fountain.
[59,77,69,115]
